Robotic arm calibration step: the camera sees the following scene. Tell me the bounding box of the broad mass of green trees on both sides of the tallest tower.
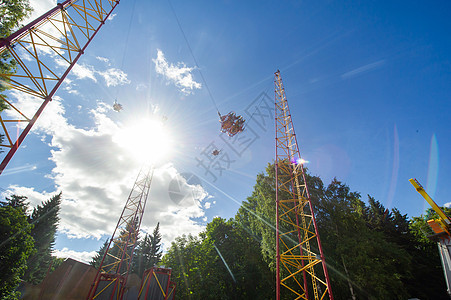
[162,164,448,299]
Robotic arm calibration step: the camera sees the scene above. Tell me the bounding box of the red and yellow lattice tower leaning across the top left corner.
[0,0,119,174]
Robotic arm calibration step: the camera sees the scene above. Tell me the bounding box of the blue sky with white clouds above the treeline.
[0,0,451,260]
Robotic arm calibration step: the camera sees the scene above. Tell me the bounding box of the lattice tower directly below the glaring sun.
[86,167,154,300]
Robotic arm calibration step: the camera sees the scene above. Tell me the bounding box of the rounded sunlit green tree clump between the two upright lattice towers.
[162,218,274,299]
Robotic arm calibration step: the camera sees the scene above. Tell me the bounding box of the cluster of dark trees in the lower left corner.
[0,193,62,299]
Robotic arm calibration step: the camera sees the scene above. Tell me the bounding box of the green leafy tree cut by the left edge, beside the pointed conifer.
[0,196,34,299]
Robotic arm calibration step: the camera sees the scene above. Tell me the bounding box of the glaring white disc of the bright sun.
[115,118,172,163]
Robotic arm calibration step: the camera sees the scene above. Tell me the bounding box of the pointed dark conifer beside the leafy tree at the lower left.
[23,193,61,284]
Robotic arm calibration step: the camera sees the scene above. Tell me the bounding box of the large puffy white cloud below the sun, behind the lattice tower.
[4,97,208,247]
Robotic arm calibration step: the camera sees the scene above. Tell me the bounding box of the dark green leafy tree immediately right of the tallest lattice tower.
[315,179,410,299]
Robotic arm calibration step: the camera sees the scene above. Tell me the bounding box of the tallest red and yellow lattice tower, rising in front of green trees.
[274,71,333,300]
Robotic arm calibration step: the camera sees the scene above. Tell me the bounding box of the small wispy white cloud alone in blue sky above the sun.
[152,49,202,94]
